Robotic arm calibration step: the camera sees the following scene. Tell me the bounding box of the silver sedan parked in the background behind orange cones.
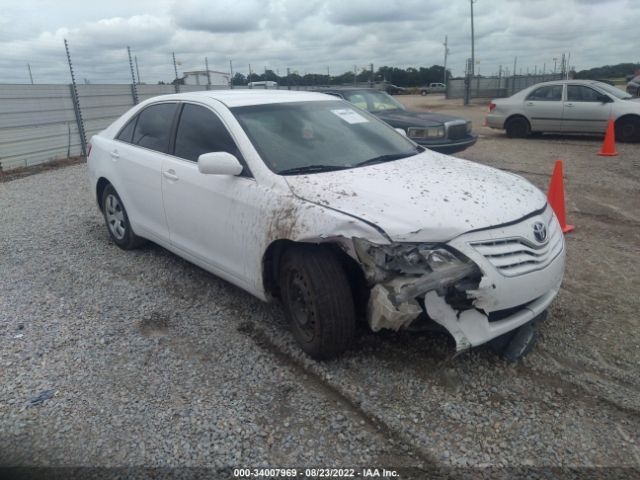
[487,80,640,142]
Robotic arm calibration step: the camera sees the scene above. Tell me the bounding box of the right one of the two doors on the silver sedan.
[562,85,611,133]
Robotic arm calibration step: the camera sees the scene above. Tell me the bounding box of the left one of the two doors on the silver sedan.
[524,84,563,132]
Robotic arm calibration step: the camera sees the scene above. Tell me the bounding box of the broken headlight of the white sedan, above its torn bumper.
[353,238,468,283]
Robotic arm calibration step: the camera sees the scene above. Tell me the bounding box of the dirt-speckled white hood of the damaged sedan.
[285,150,546,242]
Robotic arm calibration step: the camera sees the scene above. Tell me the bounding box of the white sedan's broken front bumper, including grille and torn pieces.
[369,206,565,351]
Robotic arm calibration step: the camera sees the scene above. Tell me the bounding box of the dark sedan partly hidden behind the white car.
[321,88,478,153]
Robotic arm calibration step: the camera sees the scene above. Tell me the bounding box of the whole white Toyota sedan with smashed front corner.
[88,90,565,359]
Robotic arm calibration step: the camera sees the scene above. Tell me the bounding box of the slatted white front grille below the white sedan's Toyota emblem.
[471,221,563,277]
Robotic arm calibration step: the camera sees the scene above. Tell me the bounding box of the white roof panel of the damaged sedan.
[152,88,335,107]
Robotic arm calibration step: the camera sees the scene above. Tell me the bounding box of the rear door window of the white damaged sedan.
[132,103,177,153]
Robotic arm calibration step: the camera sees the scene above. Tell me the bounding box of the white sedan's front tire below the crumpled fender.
[279,246,356,360]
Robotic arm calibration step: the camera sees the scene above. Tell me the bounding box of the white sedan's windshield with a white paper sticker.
[231,100,423,175]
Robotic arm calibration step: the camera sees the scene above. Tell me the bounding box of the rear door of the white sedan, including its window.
[109,102,178,240]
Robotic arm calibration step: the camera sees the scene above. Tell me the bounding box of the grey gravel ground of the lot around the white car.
[0,96,640,478]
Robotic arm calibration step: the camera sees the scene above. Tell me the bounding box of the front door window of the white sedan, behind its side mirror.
[174,103,242,163]
